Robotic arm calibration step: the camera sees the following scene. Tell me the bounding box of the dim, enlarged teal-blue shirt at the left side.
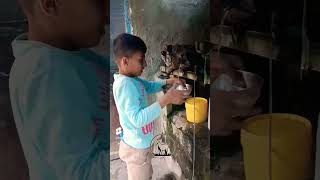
[9,35,109,180]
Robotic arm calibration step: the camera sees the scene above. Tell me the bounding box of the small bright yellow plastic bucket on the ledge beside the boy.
[185,97,208,123]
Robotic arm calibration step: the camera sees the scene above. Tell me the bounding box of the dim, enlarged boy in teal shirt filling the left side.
[9,0,109,180]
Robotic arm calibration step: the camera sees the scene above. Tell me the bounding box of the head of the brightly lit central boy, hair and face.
[113,33,147,77]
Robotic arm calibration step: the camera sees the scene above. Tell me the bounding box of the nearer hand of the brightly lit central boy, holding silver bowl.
[158,84,188,108]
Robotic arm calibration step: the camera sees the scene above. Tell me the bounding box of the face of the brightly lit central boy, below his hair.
[122,51,146,77]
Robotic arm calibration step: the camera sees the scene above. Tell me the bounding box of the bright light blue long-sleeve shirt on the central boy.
[113,74,165,149]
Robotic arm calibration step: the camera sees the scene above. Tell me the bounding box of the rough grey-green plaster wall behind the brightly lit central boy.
[129,0,210,134]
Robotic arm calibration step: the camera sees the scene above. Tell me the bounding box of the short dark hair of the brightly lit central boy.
[113,33,147,59]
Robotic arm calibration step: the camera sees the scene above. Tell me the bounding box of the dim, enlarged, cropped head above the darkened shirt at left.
[18,0,109,50]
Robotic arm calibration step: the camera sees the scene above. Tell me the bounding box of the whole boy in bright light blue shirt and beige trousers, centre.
[113,34,186,180]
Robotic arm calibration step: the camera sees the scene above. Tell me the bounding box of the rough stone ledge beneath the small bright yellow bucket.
[167,111,210,180]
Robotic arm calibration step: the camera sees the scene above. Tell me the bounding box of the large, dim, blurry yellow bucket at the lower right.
[241,114,312,180]
